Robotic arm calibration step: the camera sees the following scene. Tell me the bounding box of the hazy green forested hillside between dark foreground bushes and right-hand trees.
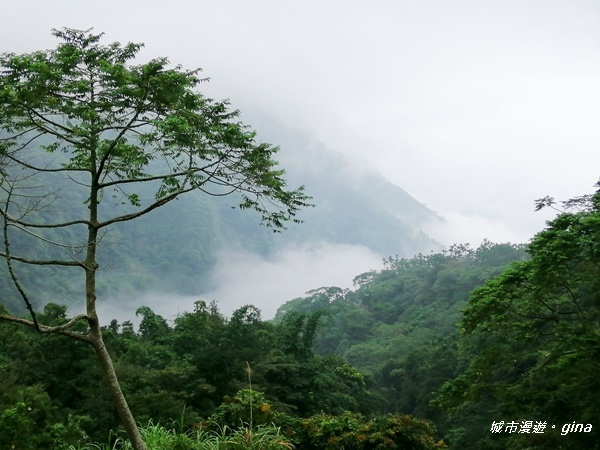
[275,241,528,438]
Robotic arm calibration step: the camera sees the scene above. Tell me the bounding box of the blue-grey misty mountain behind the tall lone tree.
[0,120,441,313]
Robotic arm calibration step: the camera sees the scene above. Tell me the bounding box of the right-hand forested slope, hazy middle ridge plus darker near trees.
[277,187,600,449]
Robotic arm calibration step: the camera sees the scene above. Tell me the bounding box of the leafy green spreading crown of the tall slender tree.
[0,28,310,230]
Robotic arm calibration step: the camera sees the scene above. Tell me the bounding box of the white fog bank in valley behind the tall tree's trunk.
[98,244,382,323]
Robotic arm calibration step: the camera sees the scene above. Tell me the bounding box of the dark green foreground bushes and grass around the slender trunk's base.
[0,301,439,449]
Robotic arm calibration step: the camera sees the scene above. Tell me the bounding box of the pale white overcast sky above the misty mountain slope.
[0,0,600,316]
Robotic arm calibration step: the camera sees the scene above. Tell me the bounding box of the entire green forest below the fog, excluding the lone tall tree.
[0,188,600,449]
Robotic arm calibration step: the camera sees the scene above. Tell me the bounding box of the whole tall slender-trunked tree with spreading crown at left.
[0,28,309,449]
